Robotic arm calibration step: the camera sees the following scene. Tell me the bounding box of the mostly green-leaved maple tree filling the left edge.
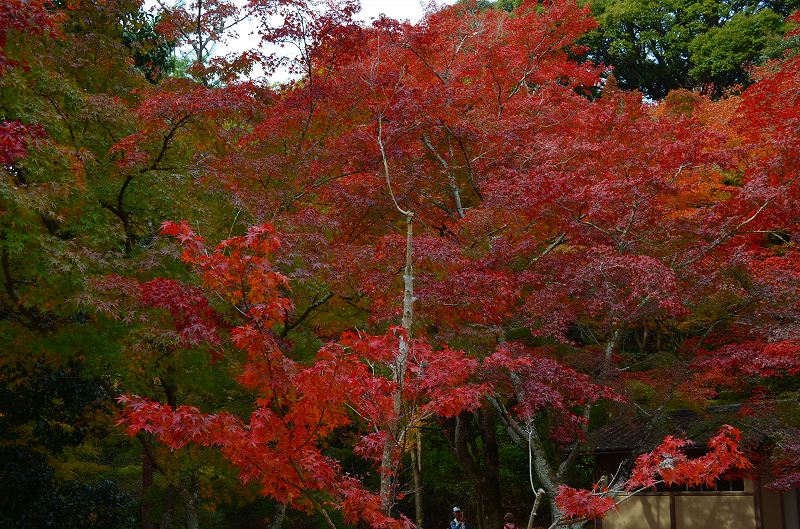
[0,0,268,527]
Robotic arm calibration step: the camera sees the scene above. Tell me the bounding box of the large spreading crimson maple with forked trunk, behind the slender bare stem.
[119,2,800,528]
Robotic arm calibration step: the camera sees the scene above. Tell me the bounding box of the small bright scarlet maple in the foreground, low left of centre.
[112,224,482,527]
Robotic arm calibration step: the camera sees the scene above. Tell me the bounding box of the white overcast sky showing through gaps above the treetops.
[144,0,456,82]
